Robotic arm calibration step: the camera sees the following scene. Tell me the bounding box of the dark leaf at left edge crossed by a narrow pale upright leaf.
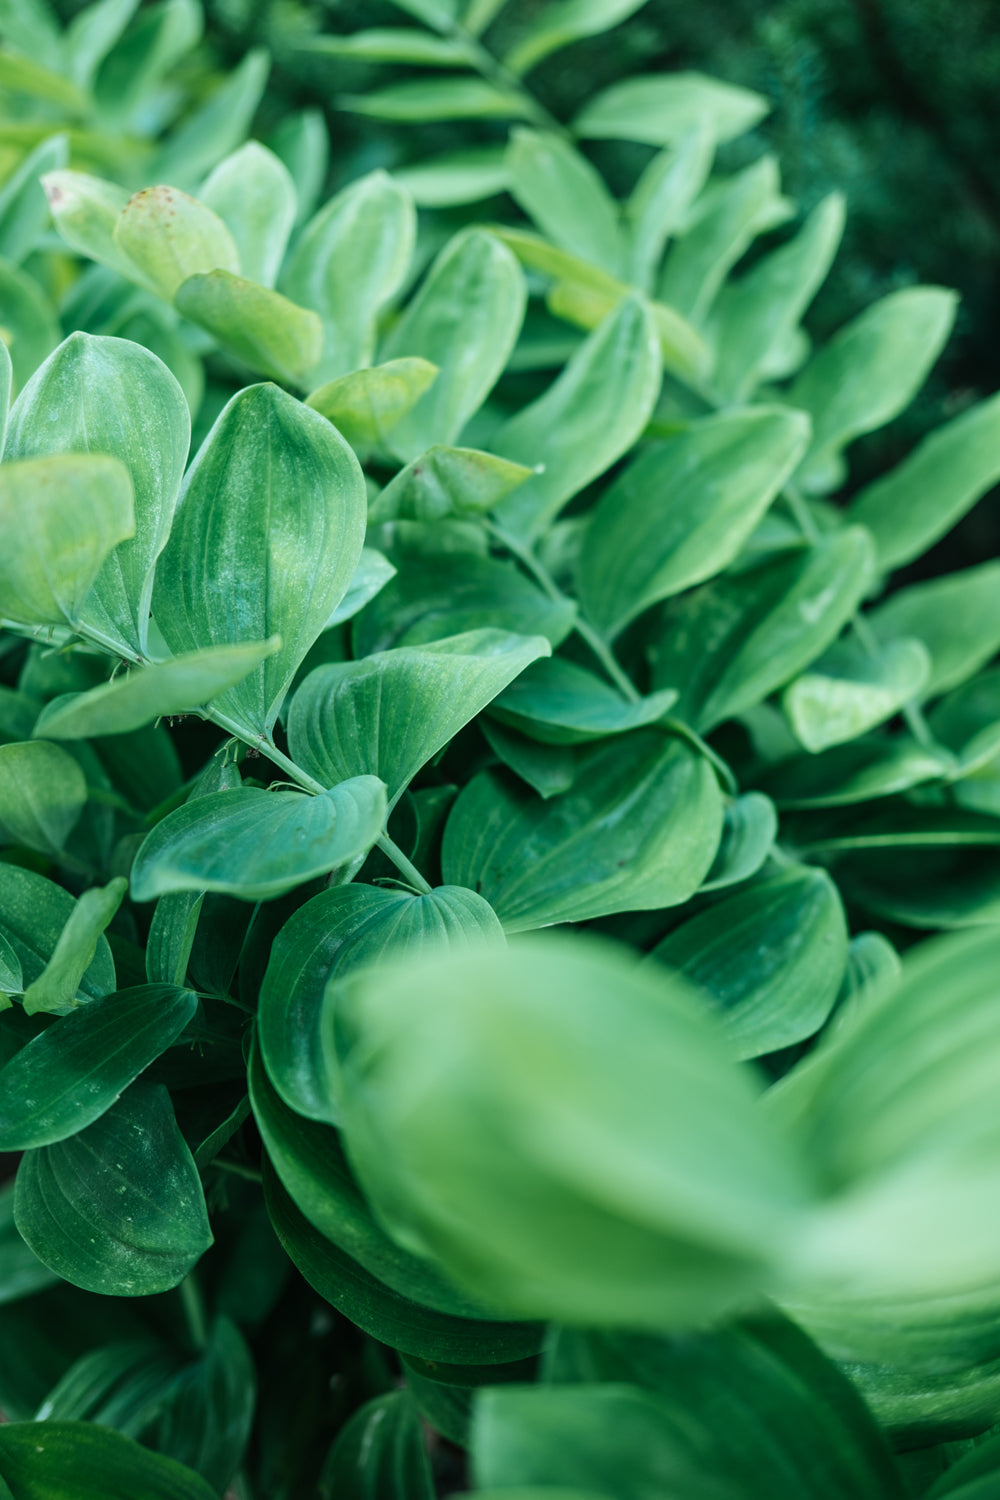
[0,861,115,1005]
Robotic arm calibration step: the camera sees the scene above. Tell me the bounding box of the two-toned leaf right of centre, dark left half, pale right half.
[651,527,869,734]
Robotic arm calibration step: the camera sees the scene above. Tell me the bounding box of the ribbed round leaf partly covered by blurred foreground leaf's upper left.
[258,884,502,1122]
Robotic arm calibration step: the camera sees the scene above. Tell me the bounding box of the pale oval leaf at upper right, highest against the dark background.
[789,287,958,494]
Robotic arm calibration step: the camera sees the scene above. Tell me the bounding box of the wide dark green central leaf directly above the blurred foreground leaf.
[442,729,723,932]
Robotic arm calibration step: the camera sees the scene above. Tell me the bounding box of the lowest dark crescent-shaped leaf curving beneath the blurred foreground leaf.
[264,1161,543,1365]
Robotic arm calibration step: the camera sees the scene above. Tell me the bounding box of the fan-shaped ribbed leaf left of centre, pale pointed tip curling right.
[289,630,549,806]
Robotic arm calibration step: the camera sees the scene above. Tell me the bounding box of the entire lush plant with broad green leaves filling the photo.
[0,0,1000,1500]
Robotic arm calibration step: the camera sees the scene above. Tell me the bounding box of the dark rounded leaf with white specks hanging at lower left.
[13,1083,211,1298]
